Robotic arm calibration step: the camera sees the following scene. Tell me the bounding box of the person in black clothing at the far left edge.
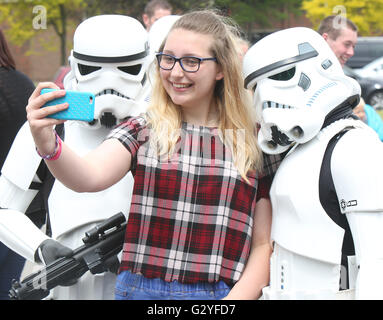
[0,29,35,300]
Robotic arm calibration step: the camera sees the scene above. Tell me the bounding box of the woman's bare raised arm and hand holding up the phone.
[26,83,131,192]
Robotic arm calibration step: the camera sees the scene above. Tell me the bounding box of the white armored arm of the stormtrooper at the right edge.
[331,129,383,299]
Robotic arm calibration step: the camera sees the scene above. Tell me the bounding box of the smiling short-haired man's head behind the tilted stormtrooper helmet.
[318,15,358,67]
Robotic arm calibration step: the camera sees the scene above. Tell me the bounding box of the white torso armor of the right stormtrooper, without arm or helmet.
[268,120,360,298]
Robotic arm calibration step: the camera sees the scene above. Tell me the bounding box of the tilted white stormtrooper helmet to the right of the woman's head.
[243,27,360,154]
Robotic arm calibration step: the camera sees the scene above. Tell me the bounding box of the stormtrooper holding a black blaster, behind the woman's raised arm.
[0,15,150,299]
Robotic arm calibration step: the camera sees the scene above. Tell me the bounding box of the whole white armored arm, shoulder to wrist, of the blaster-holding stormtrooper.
[0,122,48,261]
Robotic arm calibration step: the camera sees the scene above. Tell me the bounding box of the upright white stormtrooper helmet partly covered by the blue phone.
[64,15,150,128]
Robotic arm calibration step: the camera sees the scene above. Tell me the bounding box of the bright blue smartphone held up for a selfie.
[41,88,95,122]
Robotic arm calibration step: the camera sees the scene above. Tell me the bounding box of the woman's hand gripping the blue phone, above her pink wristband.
[26,82,68,155]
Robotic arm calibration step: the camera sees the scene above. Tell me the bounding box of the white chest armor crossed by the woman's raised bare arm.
[48,121,133,238]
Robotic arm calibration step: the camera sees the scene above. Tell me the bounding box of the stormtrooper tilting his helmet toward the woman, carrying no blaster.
[243,27,383,299]
